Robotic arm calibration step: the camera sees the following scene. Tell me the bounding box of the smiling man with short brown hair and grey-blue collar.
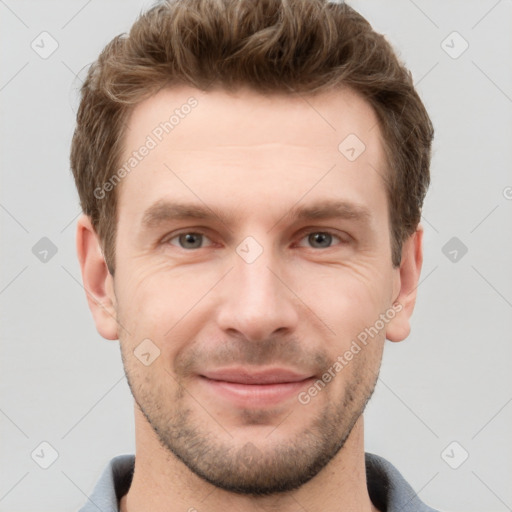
[71,0,433,512]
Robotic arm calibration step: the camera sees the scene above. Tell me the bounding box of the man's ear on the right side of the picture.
[386,224,423,341]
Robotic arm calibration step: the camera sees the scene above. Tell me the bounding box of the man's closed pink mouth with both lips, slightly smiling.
[199,368,315,407]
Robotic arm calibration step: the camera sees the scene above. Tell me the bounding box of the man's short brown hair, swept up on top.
[71,0,433,273]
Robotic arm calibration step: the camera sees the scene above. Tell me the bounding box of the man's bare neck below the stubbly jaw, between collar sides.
[120,407,378,512]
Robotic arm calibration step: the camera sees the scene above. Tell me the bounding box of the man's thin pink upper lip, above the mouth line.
[201,368,312,384]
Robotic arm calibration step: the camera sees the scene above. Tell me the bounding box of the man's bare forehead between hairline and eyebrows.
[118,87,386,228]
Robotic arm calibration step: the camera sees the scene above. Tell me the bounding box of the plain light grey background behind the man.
[0,0,512,512]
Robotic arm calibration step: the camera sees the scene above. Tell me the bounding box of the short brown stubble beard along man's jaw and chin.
[121,344,378,496]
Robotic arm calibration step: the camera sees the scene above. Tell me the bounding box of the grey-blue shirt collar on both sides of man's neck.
[79,453,438,512]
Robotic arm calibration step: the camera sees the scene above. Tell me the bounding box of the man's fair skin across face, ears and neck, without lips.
[77,87,422,512]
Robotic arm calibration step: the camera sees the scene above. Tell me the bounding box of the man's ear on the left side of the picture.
[76,215,119,340]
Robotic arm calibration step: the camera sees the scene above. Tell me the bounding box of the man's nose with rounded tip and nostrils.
[217,241,299,341]
